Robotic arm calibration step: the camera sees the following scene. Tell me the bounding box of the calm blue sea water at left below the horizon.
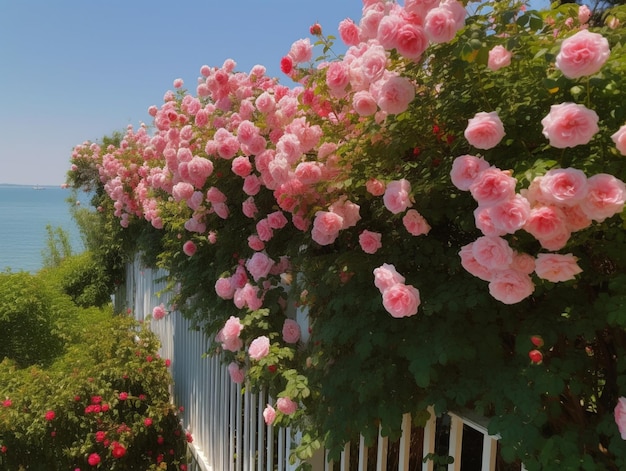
[0,185,89,273]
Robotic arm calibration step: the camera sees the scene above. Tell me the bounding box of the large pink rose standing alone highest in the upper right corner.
[556,29,610,79]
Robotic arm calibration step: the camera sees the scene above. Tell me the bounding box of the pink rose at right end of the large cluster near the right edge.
[580,173,626,222]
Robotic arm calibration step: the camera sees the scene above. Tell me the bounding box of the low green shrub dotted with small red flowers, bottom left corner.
[0,311,189,471]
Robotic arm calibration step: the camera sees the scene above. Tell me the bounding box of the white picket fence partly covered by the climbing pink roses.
[115,261,525,471]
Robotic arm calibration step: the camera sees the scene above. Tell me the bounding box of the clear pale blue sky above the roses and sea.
[0,0,544,185]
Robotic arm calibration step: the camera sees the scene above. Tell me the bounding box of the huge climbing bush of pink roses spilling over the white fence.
[64,0,626,470]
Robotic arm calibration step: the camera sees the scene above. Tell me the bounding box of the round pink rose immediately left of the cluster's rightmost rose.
[539,168,587,206]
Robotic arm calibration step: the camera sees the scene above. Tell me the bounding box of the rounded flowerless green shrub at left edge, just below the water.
[0,272,63,366]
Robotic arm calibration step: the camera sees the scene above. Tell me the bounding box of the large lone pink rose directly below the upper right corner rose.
[541,103,600,149]
